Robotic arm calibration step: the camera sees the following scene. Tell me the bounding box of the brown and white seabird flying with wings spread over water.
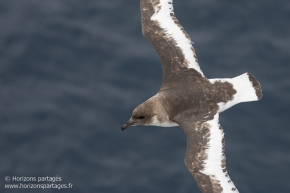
[121,0,262,193]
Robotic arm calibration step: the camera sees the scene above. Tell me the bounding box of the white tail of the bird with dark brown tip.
[209,73,262,113]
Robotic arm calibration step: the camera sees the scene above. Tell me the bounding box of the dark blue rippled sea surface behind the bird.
[0,0,290,193]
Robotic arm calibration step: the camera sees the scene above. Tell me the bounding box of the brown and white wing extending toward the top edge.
[141,0,204,88]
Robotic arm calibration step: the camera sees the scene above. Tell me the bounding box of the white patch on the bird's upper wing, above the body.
[151,0,204,76]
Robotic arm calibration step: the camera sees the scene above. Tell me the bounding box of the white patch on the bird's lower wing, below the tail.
[200,113,239,193]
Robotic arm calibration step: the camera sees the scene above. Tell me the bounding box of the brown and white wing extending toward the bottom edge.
[175,110,238,193]
